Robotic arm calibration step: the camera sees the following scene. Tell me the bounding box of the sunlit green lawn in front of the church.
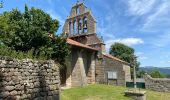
[61,84,170,100]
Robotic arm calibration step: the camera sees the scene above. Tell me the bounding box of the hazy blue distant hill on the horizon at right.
[139,66,170,75]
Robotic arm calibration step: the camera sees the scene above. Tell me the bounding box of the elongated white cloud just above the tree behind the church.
[105,38,144,51]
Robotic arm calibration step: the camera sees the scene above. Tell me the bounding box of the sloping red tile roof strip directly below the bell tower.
[67,38,98,51]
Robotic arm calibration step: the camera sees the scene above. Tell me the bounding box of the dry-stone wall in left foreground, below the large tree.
[0,57,60,100]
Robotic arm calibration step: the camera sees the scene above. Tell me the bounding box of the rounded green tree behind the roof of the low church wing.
[109,43,140,77]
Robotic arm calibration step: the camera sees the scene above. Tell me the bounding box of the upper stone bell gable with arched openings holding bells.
[63,2,96,37]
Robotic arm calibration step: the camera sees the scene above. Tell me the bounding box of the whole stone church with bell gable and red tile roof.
[61,3,131,87]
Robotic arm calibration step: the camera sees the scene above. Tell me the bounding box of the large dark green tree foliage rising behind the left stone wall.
[0,5,69,62]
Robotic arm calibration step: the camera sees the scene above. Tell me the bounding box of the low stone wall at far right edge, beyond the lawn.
[144,74,170,92]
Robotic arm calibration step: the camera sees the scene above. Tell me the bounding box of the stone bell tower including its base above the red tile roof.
[63,2,105,53]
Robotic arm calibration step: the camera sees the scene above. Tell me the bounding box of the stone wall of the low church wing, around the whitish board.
[96,57,131,86]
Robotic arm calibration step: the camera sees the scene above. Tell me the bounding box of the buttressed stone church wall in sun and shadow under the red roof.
[66,47,96,87]
